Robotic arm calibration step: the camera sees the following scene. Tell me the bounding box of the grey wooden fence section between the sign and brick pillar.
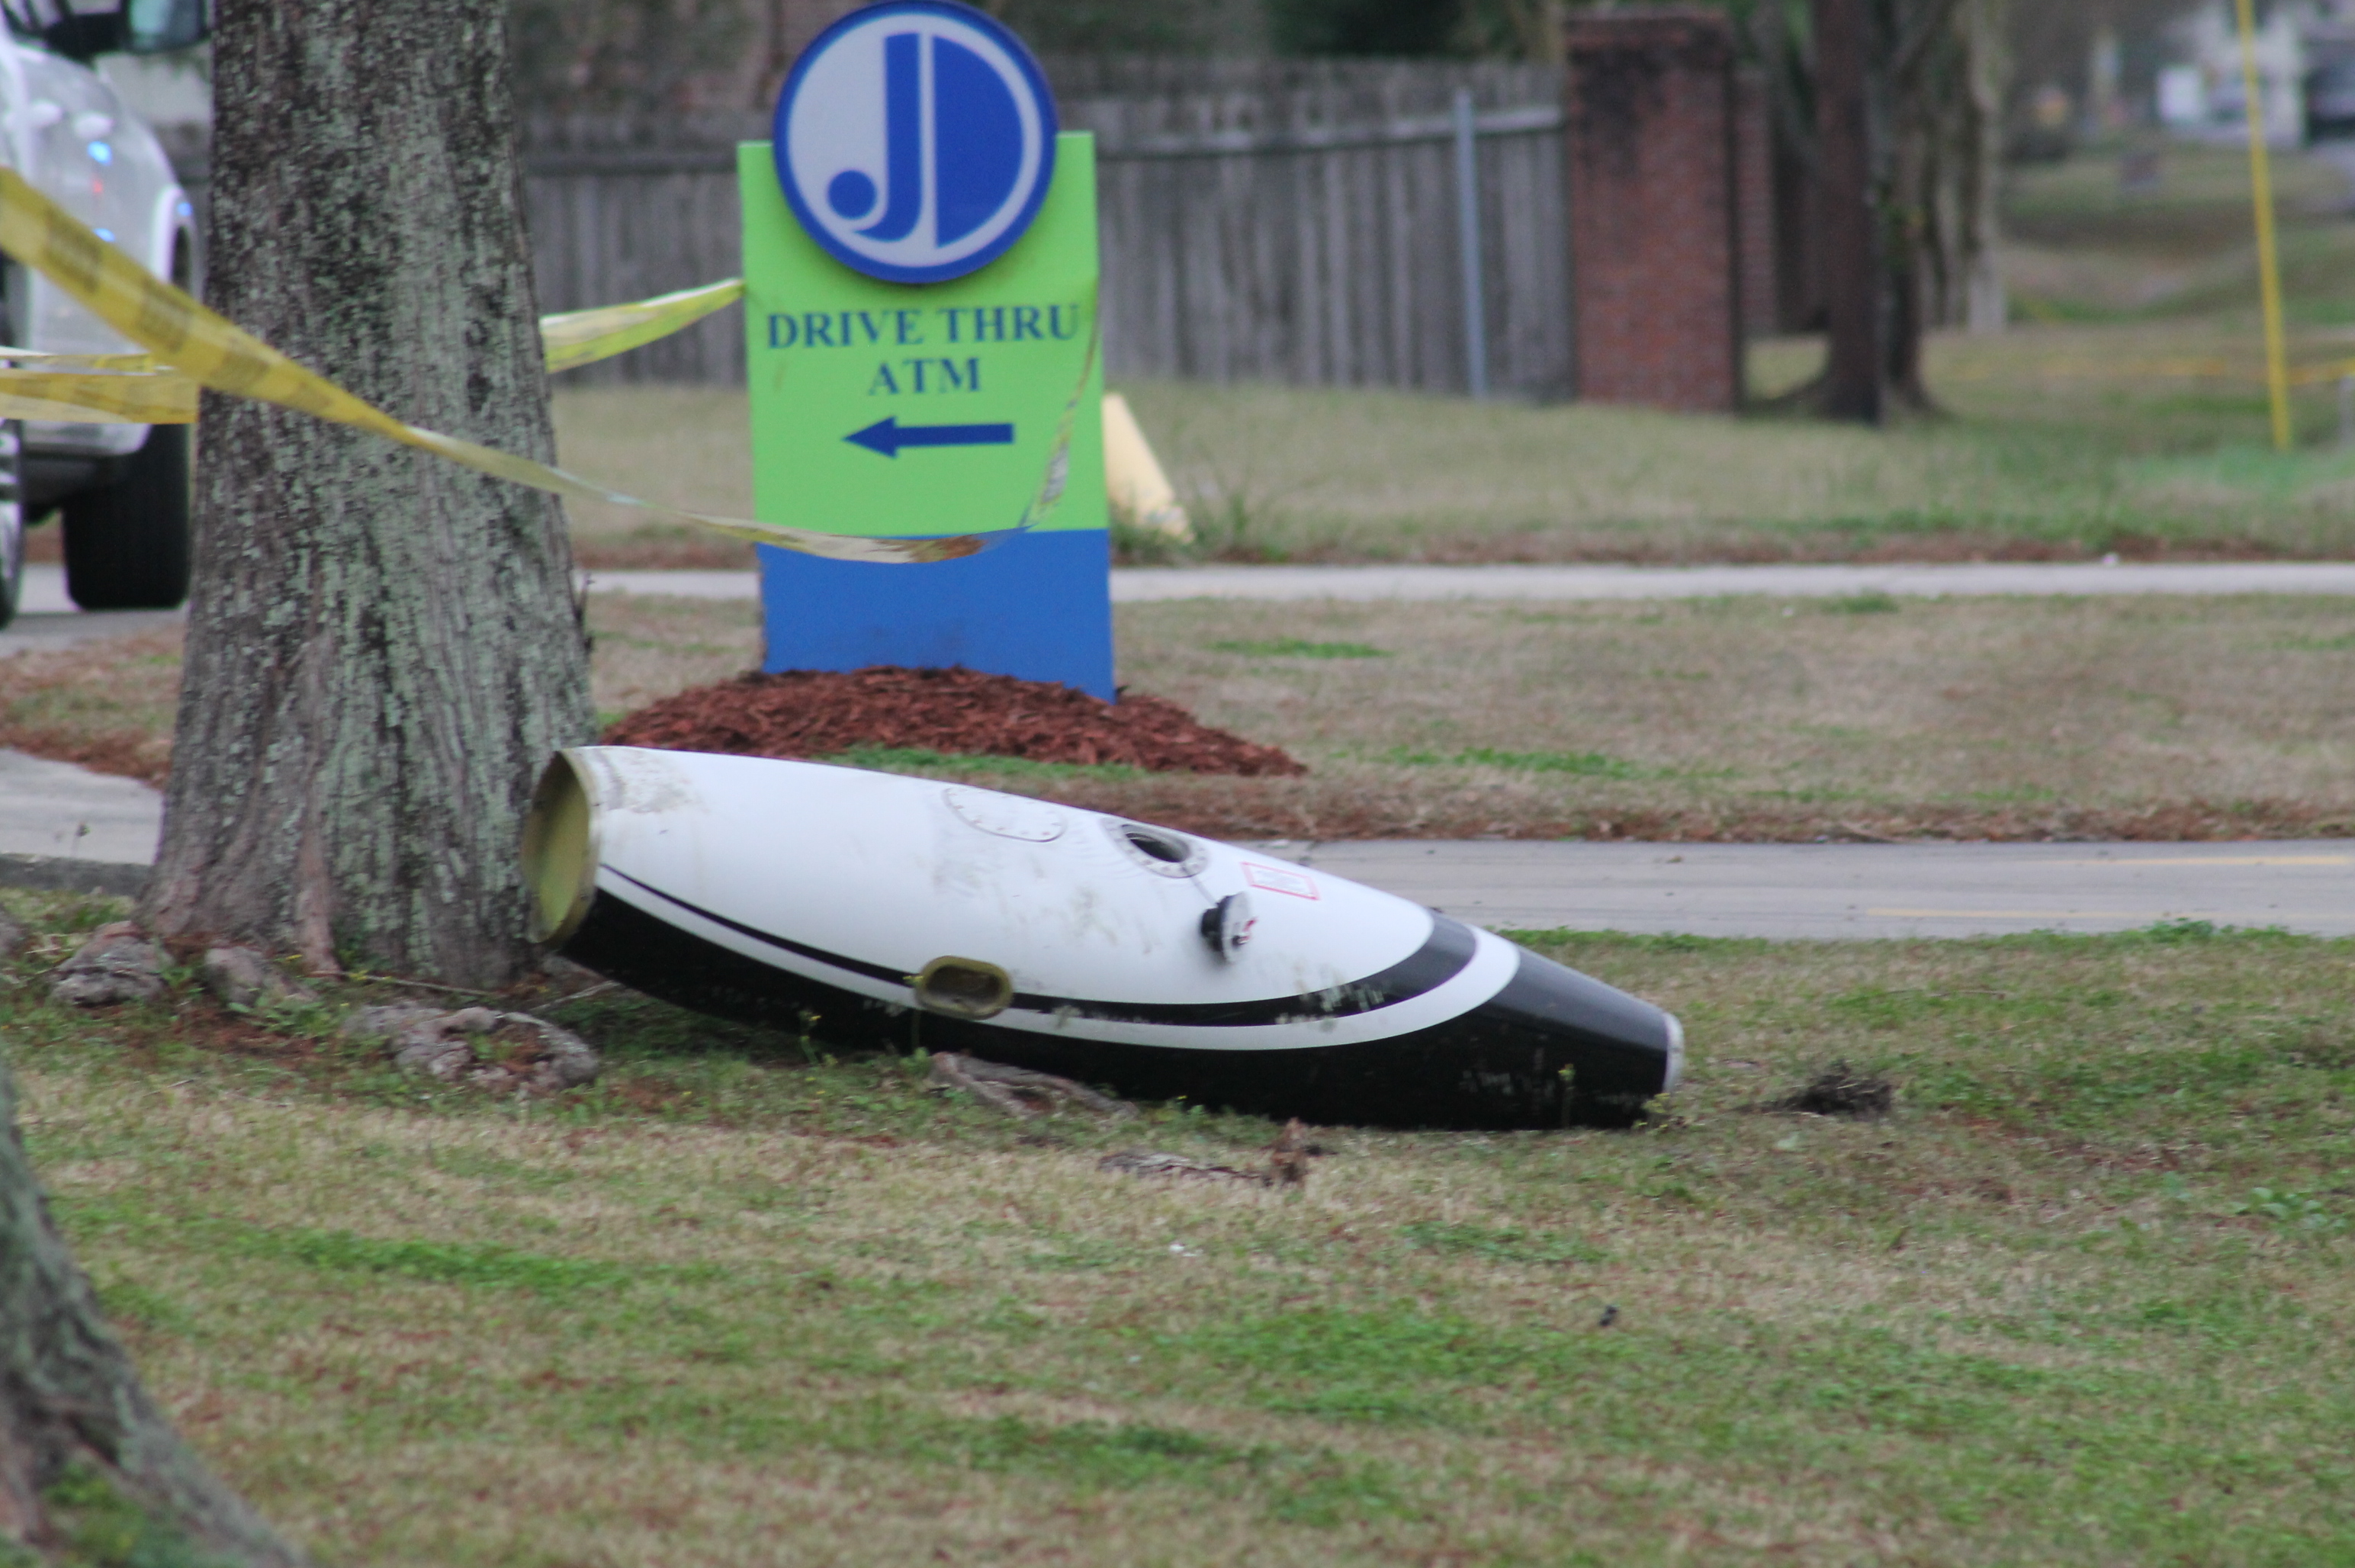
[1055,61,1571,394]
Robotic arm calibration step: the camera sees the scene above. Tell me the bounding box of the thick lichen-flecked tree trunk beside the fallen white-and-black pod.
[146,0,591,986]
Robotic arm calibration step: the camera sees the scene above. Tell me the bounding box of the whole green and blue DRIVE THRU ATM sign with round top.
[737,0,1114,699]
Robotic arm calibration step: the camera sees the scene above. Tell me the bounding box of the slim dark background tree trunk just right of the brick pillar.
[1814,0,1886,424]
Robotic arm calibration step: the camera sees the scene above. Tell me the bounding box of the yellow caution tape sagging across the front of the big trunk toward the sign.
[0,167,987,563]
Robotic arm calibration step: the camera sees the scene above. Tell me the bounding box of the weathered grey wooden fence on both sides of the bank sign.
[177,59,1571,396]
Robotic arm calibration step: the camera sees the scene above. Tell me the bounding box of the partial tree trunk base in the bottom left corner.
[0,1066,304,1568]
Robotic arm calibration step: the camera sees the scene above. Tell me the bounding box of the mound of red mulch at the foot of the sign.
[606,664,1307,777]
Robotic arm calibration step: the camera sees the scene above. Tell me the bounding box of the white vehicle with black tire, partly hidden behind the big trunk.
[0,0,210,626]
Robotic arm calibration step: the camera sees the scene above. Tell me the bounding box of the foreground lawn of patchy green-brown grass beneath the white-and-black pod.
[0,895,2355,1568]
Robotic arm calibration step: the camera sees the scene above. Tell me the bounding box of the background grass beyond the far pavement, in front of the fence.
[556,148,2355,567]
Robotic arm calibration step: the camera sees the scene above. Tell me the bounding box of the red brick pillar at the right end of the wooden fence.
[1563,7,1743,410]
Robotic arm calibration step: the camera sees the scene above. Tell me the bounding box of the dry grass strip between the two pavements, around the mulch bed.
[18,596,2355,838]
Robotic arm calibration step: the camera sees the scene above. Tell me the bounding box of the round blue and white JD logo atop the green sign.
[775,0,1055,282]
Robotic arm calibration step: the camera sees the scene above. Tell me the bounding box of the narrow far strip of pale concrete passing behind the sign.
[589,561,2355,605]
